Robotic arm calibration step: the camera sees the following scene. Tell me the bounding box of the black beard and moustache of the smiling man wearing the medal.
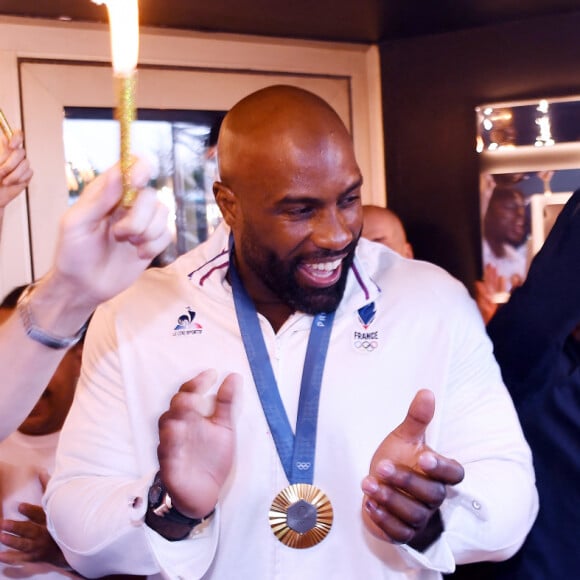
[241,227,360,314]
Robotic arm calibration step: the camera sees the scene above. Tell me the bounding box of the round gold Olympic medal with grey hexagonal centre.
[269,483,334,548]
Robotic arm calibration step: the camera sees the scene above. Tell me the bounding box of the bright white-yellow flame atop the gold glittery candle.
[93,0,139,76]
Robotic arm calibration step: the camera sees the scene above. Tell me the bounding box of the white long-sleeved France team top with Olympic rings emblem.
[45,226,537,580]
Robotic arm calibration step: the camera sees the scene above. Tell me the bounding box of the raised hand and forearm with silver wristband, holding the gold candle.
[0,161,171,439]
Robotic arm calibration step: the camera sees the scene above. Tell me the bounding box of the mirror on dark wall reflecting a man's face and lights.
[475,96,580,302]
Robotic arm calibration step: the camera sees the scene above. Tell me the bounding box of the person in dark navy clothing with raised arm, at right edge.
[462,190,580,580]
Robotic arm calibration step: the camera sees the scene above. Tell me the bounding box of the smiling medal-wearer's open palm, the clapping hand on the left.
[157,370,242,518]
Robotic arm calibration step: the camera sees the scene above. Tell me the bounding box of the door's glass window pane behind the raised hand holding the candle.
[63,107,224,264]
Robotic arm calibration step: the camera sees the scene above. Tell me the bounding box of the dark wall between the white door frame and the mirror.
[380,12,580,289]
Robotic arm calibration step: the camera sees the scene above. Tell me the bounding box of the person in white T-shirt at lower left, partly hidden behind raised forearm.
[0,286,145,580]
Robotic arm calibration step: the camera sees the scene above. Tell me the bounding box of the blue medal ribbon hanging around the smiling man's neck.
[230,252,334,484]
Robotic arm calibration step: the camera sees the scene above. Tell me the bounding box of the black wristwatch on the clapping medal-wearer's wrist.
[145,471,215,542]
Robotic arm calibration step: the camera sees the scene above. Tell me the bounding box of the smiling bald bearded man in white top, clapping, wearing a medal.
[45,86,537,580]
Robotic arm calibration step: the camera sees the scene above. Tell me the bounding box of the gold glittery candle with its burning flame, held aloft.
[93,0,139,207]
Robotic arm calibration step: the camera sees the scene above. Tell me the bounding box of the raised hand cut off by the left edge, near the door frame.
[0,131,32,239]
